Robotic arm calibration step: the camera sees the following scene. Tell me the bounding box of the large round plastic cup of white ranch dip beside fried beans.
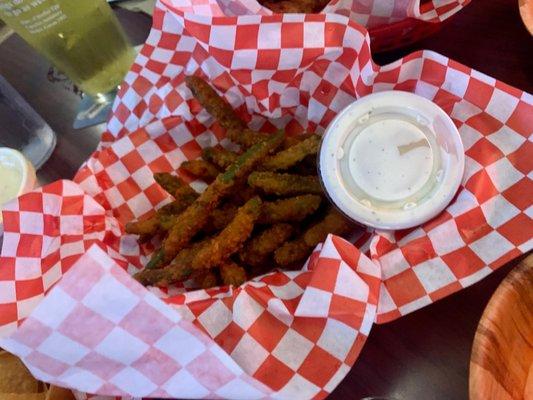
[318,91,465,229]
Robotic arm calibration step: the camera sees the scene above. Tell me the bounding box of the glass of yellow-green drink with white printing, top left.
[0,0,135,100]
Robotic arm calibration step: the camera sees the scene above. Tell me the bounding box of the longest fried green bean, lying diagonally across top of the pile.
[163,133,283,262]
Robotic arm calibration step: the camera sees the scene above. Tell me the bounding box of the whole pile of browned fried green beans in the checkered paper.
[126,77,351,288]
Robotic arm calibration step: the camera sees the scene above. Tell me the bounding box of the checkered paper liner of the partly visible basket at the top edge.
[174,0,470,29]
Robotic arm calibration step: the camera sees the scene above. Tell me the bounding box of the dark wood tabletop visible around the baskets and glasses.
[0,0,533,400]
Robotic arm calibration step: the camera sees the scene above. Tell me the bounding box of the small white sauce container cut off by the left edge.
[0,147,36,225]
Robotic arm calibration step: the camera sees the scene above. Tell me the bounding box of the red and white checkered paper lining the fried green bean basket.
[0,0,533,399]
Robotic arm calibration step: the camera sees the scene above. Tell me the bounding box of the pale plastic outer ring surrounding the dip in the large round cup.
[318,91,465,230]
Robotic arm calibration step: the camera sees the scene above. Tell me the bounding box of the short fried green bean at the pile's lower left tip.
[133,240,208,287]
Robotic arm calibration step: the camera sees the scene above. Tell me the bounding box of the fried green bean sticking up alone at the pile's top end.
[185,76,246,130]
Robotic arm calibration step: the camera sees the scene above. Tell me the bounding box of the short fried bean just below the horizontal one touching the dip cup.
[257,194,322,224]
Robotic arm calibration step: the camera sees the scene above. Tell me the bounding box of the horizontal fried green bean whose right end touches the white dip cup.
[248,171,323,196]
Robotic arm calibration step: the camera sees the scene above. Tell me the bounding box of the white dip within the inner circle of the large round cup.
[348,119,433,201]
